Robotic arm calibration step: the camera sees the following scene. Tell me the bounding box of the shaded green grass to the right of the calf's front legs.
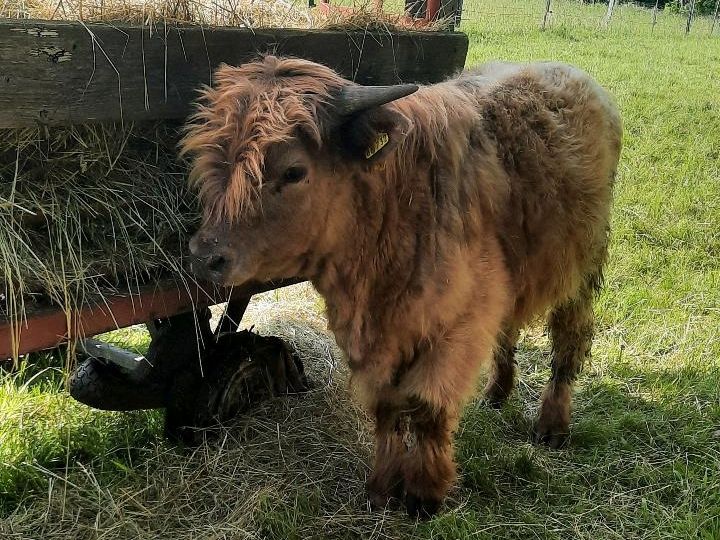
[442,343,720,538]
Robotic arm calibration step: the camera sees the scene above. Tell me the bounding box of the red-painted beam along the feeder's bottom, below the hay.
[0,280,299,359]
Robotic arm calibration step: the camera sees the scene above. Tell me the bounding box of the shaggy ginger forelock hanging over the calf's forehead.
[181,56,344,223]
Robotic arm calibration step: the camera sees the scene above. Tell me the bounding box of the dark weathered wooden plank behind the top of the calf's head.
[0,19,468,128]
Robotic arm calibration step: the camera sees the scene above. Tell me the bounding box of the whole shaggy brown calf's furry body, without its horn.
[184,57,621,516]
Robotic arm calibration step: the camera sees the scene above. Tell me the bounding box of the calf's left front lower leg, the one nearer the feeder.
[367,401,405,509]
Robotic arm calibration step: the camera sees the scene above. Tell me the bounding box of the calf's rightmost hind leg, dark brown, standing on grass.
[533,274,600,448]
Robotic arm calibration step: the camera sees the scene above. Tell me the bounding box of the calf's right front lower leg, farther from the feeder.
[403,398,457,519]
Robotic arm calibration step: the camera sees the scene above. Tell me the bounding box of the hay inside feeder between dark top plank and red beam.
[0,123,197,320]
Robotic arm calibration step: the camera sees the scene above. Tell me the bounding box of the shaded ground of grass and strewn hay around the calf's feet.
[0,328,720,538]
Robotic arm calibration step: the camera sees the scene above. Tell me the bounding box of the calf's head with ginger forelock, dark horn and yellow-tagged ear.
[182,56,417,284]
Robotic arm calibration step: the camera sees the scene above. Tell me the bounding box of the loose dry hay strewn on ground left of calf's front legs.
[0,284,422,540]
